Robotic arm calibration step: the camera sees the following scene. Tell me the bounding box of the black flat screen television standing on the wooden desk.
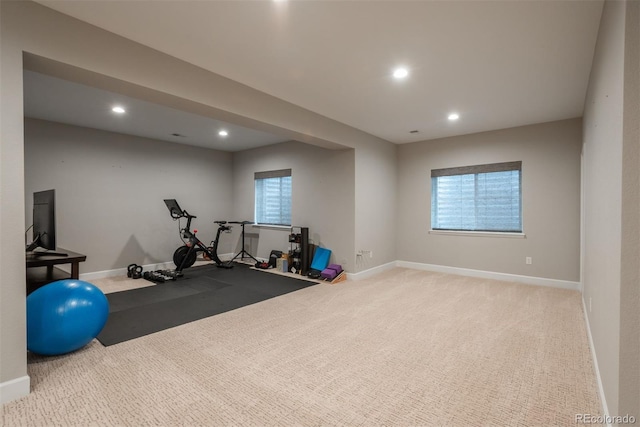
[27,190,67,256]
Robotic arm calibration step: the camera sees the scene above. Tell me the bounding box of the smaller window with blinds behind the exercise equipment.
[255,169,291,226]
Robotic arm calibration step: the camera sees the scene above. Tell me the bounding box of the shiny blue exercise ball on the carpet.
[27,279,109,356]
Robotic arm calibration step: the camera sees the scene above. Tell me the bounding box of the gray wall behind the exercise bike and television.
[25,119,232,273]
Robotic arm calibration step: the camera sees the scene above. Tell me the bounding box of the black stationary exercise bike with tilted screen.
[164,199,233,275]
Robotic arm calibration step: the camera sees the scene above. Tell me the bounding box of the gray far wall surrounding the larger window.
[398,119,581,282]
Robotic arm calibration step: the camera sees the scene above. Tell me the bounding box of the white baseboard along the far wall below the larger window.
[396,261,581,291]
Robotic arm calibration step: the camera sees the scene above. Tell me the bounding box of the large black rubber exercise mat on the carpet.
[97,264,316,346]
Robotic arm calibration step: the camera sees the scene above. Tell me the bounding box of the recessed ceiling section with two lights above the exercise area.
[24,70,288,151]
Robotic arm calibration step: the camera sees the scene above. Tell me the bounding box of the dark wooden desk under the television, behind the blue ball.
[26,248,87,295]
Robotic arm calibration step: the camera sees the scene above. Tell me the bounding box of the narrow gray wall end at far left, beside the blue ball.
[0,2,27,392]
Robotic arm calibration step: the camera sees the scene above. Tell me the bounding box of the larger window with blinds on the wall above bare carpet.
[431,162,522,233]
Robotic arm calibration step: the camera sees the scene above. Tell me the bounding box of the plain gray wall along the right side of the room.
[583,1,640,417]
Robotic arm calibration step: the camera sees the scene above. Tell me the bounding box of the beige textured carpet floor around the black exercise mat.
[1,268,600,426]
